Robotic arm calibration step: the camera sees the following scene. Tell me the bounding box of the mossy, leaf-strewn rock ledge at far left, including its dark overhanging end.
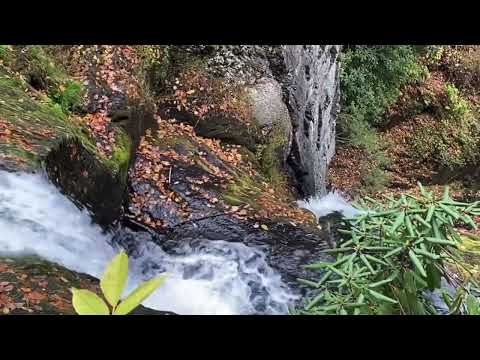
[0,45,157,227]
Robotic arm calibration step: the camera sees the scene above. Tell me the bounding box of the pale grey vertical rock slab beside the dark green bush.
[285,45,340,195]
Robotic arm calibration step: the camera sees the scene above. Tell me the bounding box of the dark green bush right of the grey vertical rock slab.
[337,45,427,191]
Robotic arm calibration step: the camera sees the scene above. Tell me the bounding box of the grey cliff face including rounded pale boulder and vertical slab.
[169,45,340,195]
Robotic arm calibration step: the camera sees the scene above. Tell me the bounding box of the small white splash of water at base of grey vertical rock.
[297,191,359,221]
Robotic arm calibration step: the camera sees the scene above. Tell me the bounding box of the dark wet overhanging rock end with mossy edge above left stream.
[45,107,156,228]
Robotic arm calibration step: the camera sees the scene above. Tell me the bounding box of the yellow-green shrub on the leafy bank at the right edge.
[411,84,480,169]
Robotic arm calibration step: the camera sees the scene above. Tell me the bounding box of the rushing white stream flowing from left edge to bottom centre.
[0,171,295,314]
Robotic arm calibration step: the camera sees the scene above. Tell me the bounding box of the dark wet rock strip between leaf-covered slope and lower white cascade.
[114,215,332,293]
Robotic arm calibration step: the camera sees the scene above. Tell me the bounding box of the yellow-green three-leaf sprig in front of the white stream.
[72,252,165,315]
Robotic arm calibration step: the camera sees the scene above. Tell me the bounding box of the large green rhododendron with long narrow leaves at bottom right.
[295,184,480,315]
